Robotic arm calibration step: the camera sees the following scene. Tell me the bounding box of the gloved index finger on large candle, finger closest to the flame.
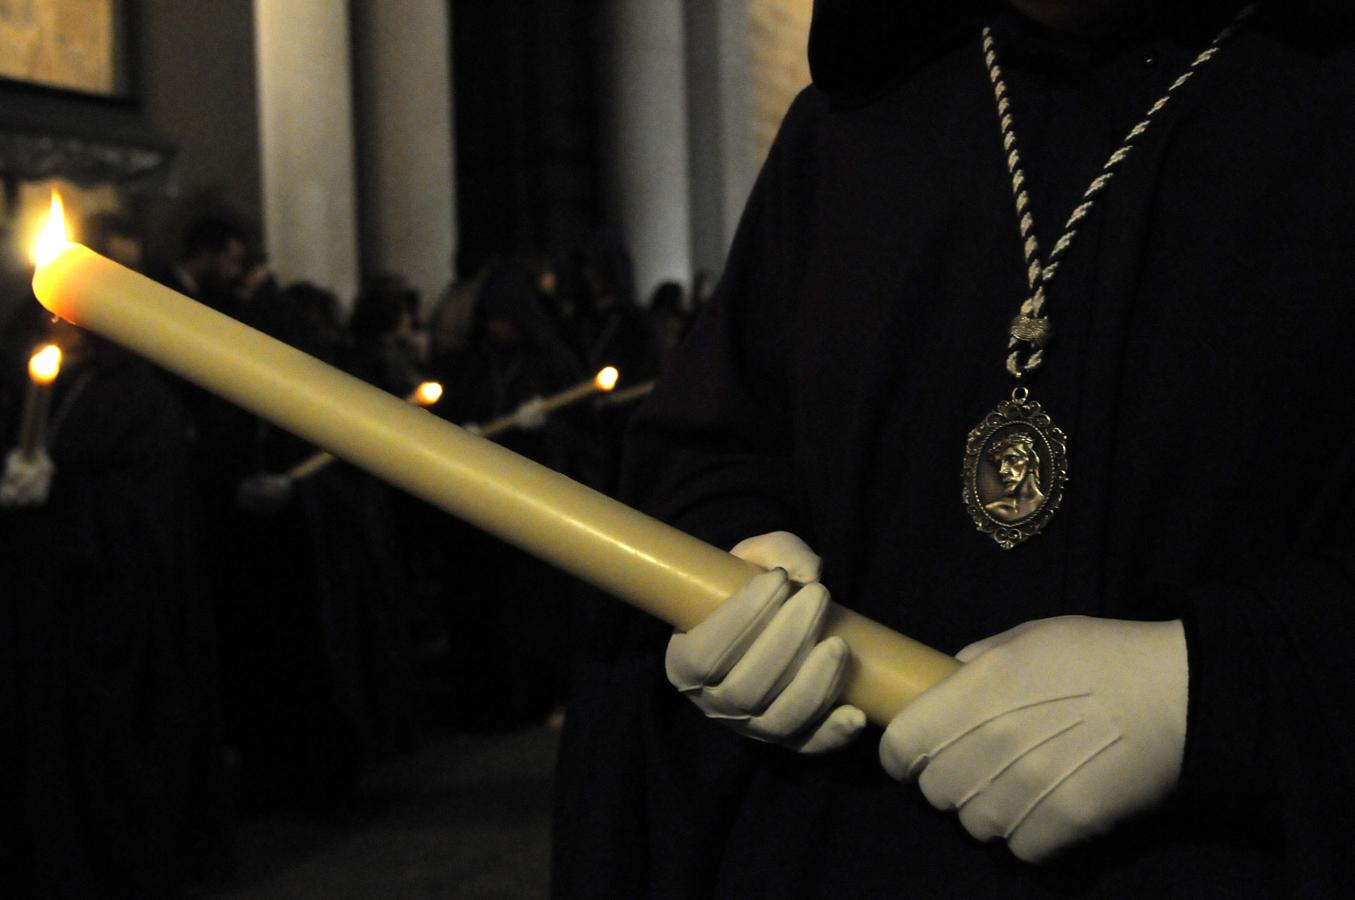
[664,569,790,691]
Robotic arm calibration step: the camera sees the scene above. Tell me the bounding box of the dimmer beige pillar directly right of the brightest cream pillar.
[352,0,457,305]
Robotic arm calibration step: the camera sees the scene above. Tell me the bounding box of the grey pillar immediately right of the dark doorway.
[602,0,691,302]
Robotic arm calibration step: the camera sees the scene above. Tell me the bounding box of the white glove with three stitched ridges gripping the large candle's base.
[879,615,1187,862]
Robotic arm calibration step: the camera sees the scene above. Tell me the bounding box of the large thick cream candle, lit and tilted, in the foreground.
[33,195,958,724]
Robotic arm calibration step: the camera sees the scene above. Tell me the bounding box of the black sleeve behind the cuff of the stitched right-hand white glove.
[1173,447,1355,896]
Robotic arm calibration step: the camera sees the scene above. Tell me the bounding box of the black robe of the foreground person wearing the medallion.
[553,0,1355,897]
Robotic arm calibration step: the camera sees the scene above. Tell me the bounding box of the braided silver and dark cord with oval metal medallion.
[963,4,1257,550]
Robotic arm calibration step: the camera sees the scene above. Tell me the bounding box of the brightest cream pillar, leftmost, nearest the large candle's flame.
[255,0,358,308]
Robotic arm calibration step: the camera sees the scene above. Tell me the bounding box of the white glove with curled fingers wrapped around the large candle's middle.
[664,531,866,754]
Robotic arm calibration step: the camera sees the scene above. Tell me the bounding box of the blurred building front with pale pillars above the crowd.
[0,0,810,321]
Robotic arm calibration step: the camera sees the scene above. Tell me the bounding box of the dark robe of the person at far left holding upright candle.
[0,327,229,897]
